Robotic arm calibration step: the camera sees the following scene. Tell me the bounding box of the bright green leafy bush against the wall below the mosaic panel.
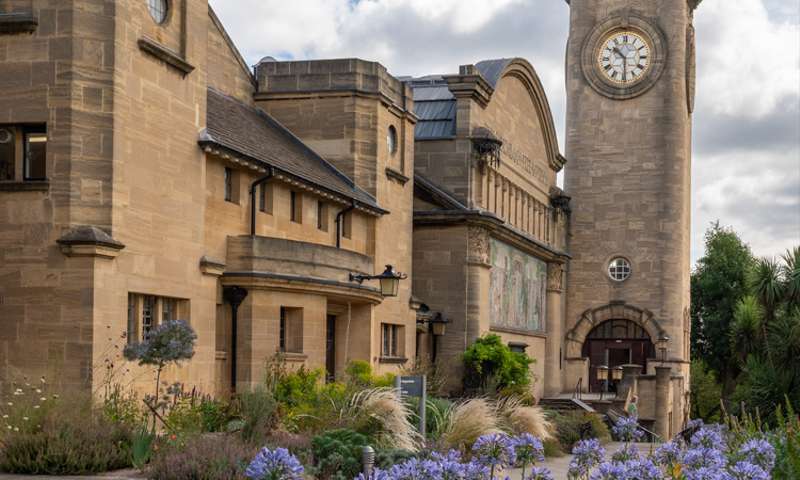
[463,334,534,393]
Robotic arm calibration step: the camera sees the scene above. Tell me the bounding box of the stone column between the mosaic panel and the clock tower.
[544,263,564,397]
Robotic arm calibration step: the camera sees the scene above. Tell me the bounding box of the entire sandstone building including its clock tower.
[0,0,694,435]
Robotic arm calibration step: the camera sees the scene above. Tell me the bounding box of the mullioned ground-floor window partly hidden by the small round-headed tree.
[128,293,189,343]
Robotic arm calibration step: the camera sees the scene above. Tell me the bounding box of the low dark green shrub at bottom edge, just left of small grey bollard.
[311,429,369,480]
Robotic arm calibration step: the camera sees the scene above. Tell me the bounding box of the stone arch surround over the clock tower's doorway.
[565,302,669,358]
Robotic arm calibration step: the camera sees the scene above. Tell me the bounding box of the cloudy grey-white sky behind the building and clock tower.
[211,0,800,259]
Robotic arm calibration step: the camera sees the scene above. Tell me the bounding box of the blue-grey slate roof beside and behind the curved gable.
[403,58,514,140]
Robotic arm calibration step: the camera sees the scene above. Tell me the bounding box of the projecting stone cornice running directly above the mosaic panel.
[414,210,571,263]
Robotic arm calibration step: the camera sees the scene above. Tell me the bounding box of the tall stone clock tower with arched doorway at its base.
[564,0,696,436]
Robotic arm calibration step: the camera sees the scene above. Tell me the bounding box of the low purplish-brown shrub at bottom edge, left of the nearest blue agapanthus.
[145,434,257,480]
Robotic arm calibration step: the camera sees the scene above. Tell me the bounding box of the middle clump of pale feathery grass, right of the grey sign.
[441,398,500,452]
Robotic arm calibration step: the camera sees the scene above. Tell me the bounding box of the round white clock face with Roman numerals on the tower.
[597,30,652,86]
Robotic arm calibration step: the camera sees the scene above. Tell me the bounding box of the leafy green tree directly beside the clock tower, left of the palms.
[691,222,754,390]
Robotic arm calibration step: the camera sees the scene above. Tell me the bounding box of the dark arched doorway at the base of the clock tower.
[581,319,655,392]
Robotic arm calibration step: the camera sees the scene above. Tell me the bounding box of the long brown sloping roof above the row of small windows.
[199,88,386,213]
